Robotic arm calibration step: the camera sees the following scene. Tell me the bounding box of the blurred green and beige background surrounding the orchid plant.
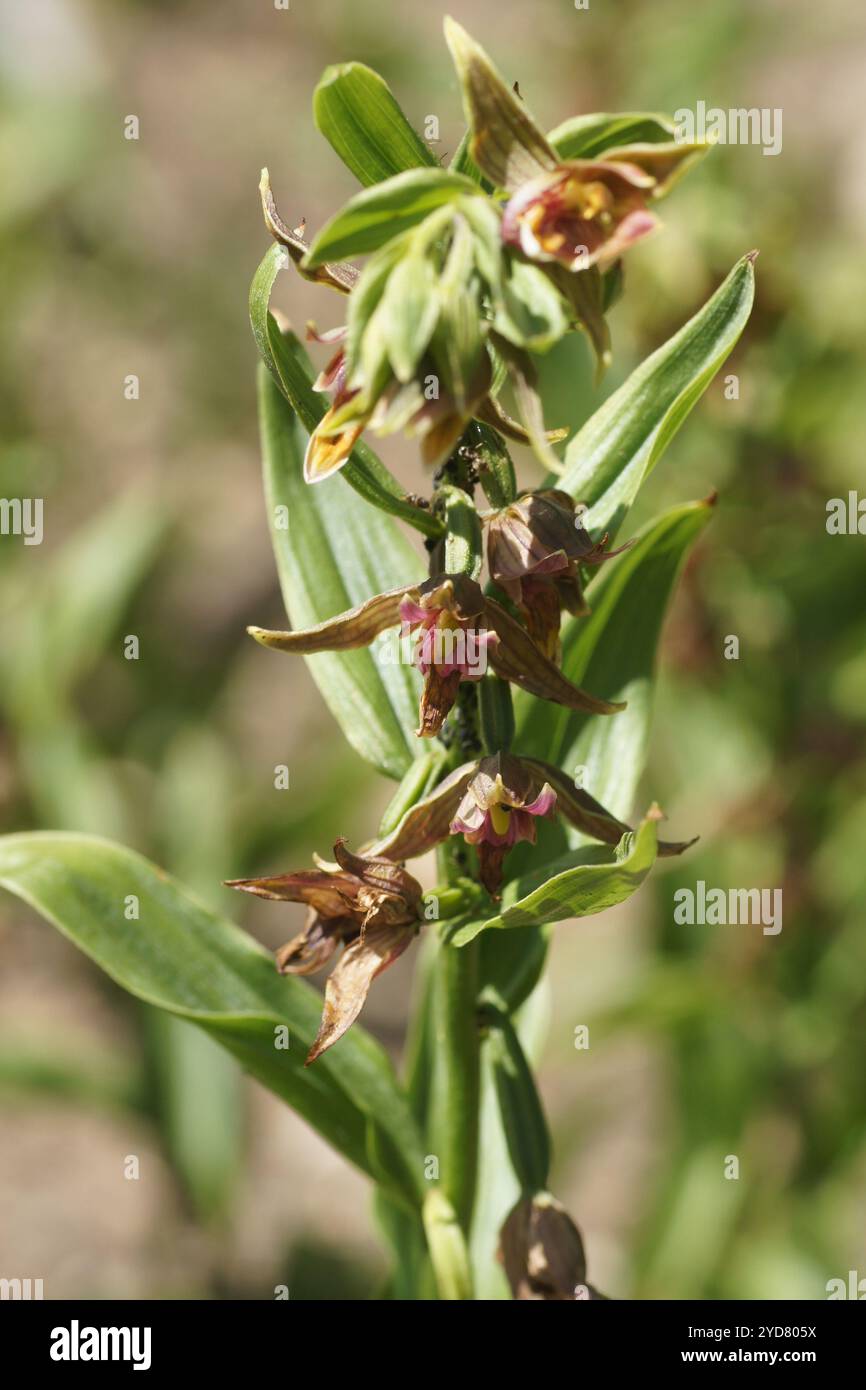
[0,0,866,1298]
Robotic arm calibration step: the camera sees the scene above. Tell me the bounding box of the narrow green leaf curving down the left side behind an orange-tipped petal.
[250,245,442,537]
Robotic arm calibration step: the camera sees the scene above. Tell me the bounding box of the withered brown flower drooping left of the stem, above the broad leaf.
[228,840,421,1066]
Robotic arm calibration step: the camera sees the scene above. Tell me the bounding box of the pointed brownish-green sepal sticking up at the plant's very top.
[445,17,557,192]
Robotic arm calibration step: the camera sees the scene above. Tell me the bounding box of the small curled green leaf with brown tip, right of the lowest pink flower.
[453,816,657,947]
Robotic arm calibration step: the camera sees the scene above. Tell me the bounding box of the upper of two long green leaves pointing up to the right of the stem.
[556,252,758,535]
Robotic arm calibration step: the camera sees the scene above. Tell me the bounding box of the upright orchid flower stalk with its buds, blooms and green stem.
[234,19,722,1301]
